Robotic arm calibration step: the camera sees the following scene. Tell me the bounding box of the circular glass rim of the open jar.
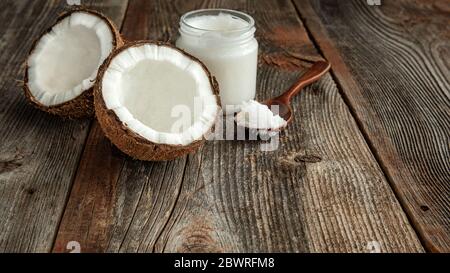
[180,8,255,33]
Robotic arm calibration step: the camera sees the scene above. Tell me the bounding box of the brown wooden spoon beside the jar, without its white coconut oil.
[262,61,331,127]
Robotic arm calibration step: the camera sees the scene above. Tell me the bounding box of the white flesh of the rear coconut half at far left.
[28,11,114,106]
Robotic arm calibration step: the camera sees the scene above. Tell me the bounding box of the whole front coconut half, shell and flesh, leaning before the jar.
[94,41,220,161]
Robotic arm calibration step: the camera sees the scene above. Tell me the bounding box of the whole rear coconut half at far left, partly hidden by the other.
[24,8,123,118]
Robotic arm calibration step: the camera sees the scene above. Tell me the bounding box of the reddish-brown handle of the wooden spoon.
[278,61,331,104]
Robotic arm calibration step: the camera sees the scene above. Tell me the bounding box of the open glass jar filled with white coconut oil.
[177,9,258,114]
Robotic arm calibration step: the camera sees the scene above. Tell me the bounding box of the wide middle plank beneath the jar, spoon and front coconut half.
[54,0,423,252]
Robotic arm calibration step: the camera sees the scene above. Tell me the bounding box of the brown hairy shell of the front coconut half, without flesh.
[94,41,220,161]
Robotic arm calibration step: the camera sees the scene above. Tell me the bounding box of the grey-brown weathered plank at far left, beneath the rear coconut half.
[0,0,126,252]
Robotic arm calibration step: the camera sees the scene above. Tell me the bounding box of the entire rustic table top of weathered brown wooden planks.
[0,0,450,252]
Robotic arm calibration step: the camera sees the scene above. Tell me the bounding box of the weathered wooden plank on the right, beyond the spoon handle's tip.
[296,0,450,252]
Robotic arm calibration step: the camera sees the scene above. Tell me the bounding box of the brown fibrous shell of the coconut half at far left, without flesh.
[23,7,124,118]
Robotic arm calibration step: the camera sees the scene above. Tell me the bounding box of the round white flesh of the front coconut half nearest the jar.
[101,44,220,145]
